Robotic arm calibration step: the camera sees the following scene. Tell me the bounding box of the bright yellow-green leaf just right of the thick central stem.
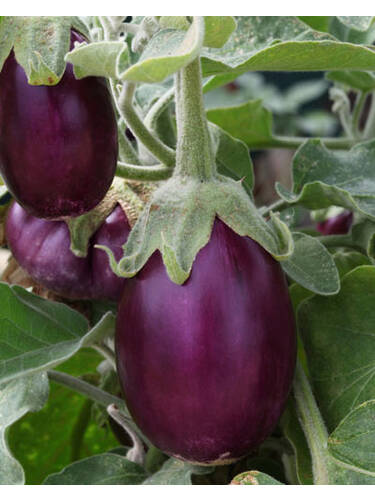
[207,99,273,148]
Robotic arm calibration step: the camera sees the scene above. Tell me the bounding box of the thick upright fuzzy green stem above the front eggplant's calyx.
[175,57,215,181]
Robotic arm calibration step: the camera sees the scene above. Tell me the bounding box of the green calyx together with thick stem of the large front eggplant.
[99,47,294,284]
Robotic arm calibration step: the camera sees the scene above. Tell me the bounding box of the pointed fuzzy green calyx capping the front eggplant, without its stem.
[113,175,293,284]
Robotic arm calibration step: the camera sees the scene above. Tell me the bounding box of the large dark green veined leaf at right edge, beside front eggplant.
[298,266,375,431]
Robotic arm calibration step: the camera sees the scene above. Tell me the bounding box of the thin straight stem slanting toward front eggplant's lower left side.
[47,370,126,411]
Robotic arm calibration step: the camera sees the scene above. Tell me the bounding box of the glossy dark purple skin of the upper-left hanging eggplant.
[0,31,118,219]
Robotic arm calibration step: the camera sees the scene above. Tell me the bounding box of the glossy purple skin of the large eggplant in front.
[116,219,296,464]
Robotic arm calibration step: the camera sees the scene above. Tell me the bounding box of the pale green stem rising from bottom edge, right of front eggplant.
[293,361,330,484]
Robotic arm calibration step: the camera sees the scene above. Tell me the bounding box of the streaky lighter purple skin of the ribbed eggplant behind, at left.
[5,202,130,301]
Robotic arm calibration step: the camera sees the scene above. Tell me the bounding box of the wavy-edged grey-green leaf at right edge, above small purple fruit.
[276,139,375,219]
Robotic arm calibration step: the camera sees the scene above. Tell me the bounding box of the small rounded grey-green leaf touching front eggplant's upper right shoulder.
[282,233,340,295]
